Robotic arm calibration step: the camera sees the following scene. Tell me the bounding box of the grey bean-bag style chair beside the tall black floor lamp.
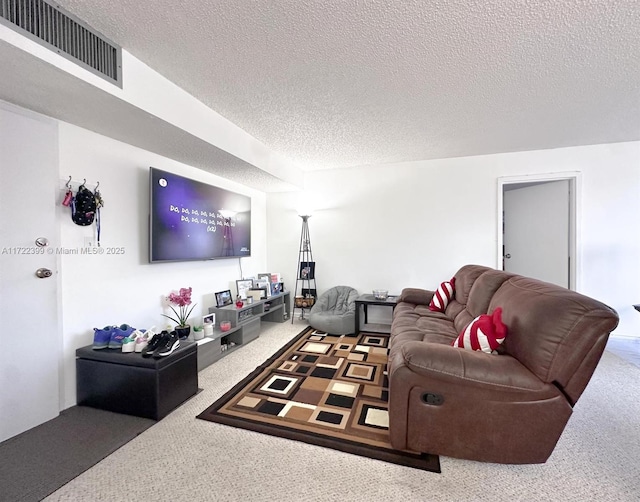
[309,286,358,335]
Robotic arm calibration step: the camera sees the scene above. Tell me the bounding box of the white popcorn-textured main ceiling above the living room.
[1,0,640,176]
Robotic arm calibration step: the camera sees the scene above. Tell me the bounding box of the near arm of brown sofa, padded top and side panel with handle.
[389,341,572,464]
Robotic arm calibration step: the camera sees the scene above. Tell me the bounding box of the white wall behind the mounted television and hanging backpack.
[56,122,267,408]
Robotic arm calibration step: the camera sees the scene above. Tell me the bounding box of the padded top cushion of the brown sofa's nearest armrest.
[390,341,547,391]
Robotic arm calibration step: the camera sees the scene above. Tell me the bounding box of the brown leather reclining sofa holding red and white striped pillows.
[388,265,618,464]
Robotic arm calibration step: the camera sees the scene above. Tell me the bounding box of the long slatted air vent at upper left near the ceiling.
[0,0,122,87]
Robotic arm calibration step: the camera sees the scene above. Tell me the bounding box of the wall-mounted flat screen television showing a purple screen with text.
[149,167,251,263]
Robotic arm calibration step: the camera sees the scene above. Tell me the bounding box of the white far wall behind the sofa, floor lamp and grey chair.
[267,142,640,336]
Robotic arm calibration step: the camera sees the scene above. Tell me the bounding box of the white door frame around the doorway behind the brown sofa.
[496,171,582,291]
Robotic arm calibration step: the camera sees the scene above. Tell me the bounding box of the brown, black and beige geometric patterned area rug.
[197,328,440,473]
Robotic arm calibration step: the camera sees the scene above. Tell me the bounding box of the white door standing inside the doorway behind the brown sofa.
[503,180,570,288]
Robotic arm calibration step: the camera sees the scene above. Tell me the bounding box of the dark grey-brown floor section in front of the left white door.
[0,406,156,502]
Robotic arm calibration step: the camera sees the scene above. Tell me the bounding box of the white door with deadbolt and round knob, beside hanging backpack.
[0,103,61,441]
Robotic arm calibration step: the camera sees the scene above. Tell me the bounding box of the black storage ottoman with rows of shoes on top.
[76,340,198,420]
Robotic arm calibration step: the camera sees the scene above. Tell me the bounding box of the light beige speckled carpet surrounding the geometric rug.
[45,320,640,502]
